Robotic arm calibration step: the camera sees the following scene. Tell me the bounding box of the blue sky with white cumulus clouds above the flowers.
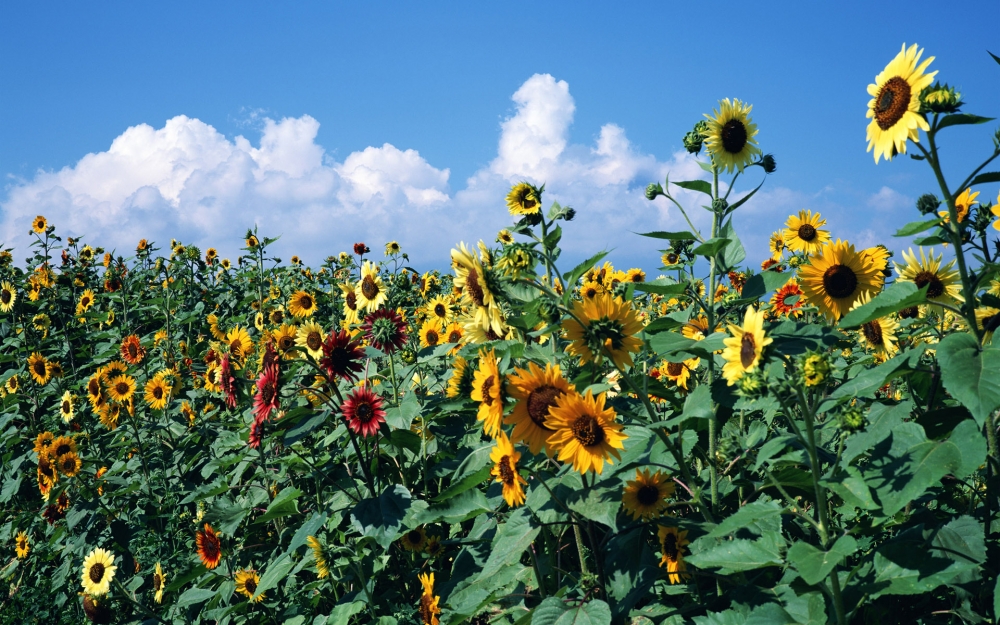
[0,0,1000,269]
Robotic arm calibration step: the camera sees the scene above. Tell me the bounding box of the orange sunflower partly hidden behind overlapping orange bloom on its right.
[505,362,576,456]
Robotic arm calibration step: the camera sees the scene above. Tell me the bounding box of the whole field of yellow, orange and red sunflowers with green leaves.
[0,45,1000,625]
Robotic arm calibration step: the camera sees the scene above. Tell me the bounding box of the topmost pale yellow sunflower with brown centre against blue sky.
[866,43,937,163]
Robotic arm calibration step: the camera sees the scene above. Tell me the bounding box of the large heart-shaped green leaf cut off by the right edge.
[937,333,1000,427]
